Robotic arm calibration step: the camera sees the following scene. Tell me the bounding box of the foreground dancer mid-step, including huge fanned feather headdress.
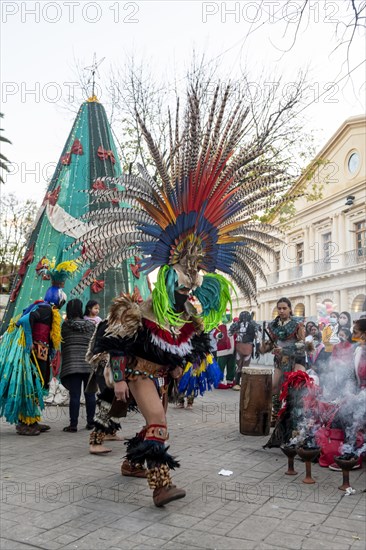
[68,83,289,506]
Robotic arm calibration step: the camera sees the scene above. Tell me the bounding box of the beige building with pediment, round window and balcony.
[235,115,366,321]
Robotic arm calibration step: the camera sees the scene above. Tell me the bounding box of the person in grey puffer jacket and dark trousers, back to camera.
[60,298,95,432]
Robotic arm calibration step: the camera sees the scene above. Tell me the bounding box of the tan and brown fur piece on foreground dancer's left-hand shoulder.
[105,294,142,338]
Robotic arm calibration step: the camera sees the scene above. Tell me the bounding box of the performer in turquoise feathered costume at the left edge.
[0,259,77,435]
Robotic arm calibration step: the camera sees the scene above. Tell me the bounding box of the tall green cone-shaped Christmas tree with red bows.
[1,96,149,332]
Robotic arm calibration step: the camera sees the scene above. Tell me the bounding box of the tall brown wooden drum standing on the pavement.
[240,367,272,435]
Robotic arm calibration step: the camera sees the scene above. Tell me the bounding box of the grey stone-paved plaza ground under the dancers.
[0,390,366,550]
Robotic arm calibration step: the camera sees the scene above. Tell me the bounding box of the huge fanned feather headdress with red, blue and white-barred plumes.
[73,86,289,330]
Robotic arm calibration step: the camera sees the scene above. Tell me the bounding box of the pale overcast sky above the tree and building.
[1,0,365,202]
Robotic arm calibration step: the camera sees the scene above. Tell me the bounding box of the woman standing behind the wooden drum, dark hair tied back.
[260,298,306,426]
